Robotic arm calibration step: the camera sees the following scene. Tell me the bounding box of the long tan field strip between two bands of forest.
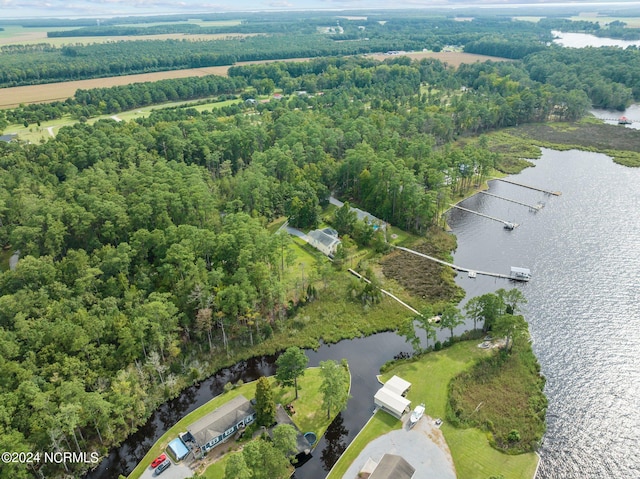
[0,52,506,108]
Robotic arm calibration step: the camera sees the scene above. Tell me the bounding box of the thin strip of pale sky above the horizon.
[0,0,640,21]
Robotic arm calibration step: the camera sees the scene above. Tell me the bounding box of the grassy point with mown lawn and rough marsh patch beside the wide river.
[327,340,546,479]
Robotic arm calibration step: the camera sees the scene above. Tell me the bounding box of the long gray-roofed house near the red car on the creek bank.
[187,395,256,455]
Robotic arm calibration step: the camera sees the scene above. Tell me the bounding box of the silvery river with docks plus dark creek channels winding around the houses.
[87,150,640,479]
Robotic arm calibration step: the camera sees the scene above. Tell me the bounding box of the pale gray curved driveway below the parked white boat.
[342,414,456,479]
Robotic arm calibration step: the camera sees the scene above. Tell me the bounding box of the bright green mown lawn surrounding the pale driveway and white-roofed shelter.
[327,341,538,479]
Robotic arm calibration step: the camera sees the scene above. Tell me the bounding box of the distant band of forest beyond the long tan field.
[0,15,551,88]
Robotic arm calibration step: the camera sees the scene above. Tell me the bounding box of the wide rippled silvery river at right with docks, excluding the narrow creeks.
[450,150,640,479]
